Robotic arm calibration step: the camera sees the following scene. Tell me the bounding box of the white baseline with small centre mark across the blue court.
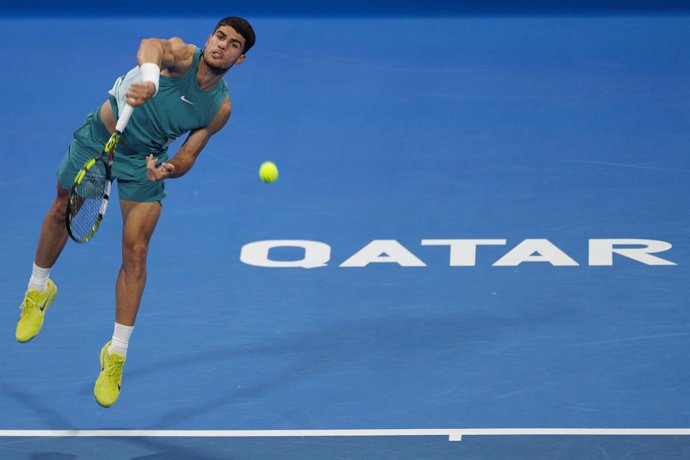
[0,428,690,441]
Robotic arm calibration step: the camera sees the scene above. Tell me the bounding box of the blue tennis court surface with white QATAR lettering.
[0,2,690,459]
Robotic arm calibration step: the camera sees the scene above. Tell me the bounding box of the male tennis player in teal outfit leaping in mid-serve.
[16,17,255,407]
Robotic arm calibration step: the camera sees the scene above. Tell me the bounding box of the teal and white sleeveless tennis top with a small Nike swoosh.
[108,48,228,158]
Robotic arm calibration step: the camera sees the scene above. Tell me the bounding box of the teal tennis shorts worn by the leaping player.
[57,109,166,203]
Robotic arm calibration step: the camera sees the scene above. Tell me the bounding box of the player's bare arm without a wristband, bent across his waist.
[146,97,231,181]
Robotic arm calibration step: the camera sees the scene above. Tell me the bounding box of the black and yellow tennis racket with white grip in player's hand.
[67,105,133,243]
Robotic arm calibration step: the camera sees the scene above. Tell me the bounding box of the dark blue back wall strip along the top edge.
[0,0,690,16]
